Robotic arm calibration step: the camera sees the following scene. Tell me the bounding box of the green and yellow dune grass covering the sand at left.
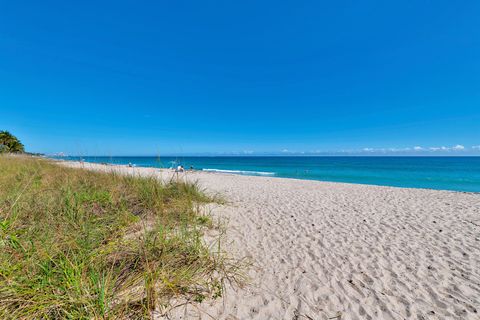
[0,155,236,319]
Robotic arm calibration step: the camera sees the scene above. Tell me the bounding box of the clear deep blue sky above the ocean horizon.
[0,0,480,155]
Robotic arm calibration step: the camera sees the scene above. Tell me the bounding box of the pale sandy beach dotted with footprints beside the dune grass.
[61,162,480,320]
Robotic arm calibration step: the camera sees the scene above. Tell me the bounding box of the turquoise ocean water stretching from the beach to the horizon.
[52,156,480,192]
